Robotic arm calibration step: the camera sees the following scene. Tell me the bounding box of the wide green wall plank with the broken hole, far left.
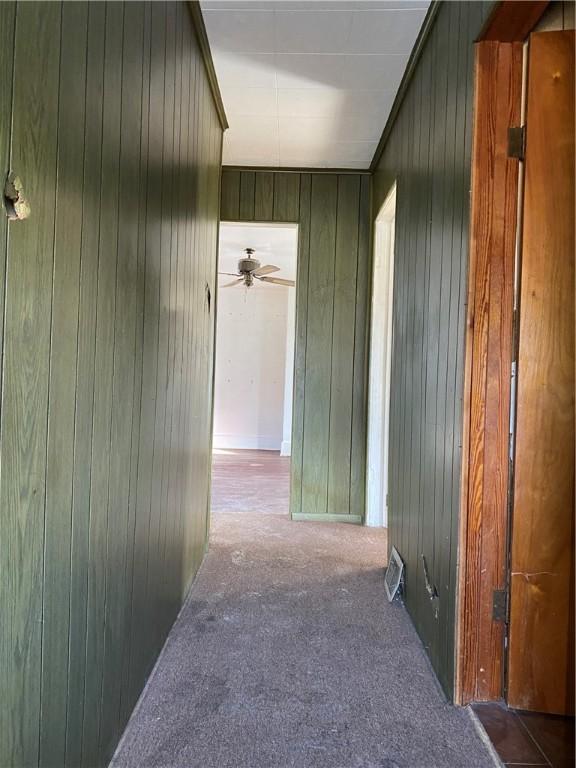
[0,3,61,766]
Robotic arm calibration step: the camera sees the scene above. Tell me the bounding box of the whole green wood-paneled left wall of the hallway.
[0,2,222,768]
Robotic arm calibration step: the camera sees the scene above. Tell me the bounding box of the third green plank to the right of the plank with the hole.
[82,3,124,762]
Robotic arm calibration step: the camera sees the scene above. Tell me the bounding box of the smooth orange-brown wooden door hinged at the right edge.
[508,32,574,714]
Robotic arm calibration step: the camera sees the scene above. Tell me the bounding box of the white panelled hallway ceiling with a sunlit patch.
[201,0,429,168]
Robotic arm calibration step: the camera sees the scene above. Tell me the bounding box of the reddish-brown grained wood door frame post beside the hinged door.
[455,41,522,704]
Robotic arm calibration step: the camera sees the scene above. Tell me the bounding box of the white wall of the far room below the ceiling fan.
[214,285,294,451]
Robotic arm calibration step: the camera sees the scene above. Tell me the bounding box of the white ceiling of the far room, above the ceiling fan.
[218,223,298,285]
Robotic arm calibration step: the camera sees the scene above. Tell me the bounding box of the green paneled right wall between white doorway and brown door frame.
[373,2,493,696]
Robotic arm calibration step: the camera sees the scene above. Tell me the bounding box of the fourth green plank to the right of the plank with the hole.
[99,3,144,754]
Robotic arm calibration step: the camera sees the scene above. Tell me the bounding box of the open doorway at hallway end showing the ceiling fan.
[213,222,298,515]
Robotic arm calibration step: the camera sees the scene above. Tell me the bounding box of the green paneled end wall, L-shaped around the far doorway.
[221,169,370,523]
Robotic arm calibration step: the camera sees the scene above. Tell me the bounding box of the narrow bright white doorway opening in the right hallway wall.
[366,184,396,527]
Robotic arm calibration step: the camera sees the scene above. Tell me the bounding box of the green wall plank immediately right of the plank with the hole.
[40,3,88,765]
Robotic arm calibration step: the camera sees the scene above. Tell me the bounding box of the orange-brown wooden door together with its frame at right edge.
[457,3,574,728]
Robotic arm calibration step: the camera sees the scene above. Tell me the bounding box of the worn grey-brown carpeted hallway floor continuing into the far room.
[112,451,498,768]
